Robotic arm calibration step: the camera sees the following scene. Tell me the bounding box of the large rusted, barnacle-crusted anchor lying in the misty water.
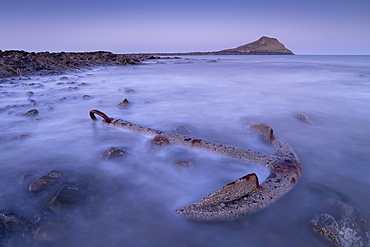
[90,110,301,221]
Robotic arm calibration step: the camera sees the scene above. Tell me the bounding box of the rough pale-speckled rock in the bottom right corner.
[310,202,370,247]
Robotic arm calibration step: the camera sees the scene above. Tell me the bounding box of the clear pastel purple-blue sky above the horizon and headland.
[0,0,370,55]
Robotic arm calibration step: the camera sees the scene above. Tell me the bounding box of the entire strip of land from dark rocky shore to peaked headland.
[0,36,294,78]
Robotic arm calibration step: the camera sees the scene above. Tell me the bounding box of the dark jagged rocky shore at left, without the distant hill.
[0,50,160,78]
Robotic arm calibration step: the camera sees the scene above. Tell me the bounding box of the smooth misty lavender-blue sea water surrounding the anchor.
[0,56,370,247]
